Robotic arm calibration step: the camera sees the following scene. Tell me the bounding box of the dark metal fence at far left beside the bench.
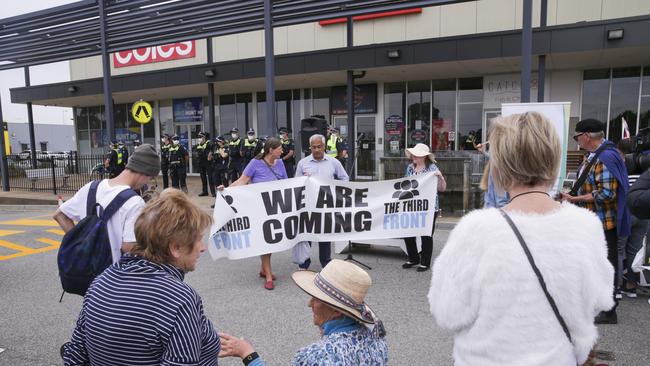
[0,151,104,194]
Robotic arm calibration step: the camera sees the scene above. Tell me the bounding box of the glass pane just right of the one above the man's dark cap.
[608,67,641,142]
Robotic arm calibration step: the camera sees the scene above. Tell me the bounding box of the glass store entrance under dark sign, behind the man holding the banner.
[332,114,377,180]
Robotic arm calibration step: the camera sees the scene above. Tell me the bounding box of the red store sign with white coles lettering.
[113,41,196,68]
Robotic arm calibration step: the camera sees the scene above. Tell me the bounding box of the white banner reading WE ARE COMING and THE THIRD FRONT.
[208,173,438,259]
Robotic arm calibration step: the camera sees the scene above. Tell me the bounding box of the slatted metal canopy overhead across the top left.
[0,0,470,70]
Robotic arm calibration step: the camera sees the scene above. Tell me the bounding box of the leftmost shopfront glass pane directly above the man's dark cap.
[580,69,609,126]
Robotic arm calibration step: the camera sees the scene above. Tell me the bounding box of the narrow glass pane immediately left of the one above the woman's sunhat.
[384,83,406,156]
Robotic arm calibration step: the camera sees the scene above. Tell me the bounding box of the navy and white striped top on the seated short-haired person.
[64,254,220,366]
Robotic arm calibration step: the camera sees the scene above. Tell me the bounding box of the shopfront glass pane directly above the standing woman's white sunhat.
[406,80,431,146]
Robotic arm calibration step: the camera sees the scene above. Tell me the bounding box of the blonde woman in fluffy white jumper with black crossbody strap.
[428,112,614,366]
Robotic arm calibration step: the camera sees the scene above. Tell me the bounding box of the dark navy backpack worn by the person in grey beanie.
[57,180,136,298]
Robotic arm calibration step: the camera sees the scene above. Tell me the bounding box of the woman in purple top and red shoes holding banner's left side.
[218,137,288,290]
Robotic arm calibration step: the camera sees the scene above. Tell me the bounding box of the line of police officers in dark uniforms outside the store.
[104,127,347,197]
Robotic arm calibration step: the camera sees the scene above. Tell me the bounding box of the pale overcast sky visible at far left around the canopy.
[0,0,74,124]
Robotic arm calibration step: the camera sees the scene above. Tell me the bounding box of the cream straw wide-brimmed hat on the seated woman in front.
[291,259,386,337]
